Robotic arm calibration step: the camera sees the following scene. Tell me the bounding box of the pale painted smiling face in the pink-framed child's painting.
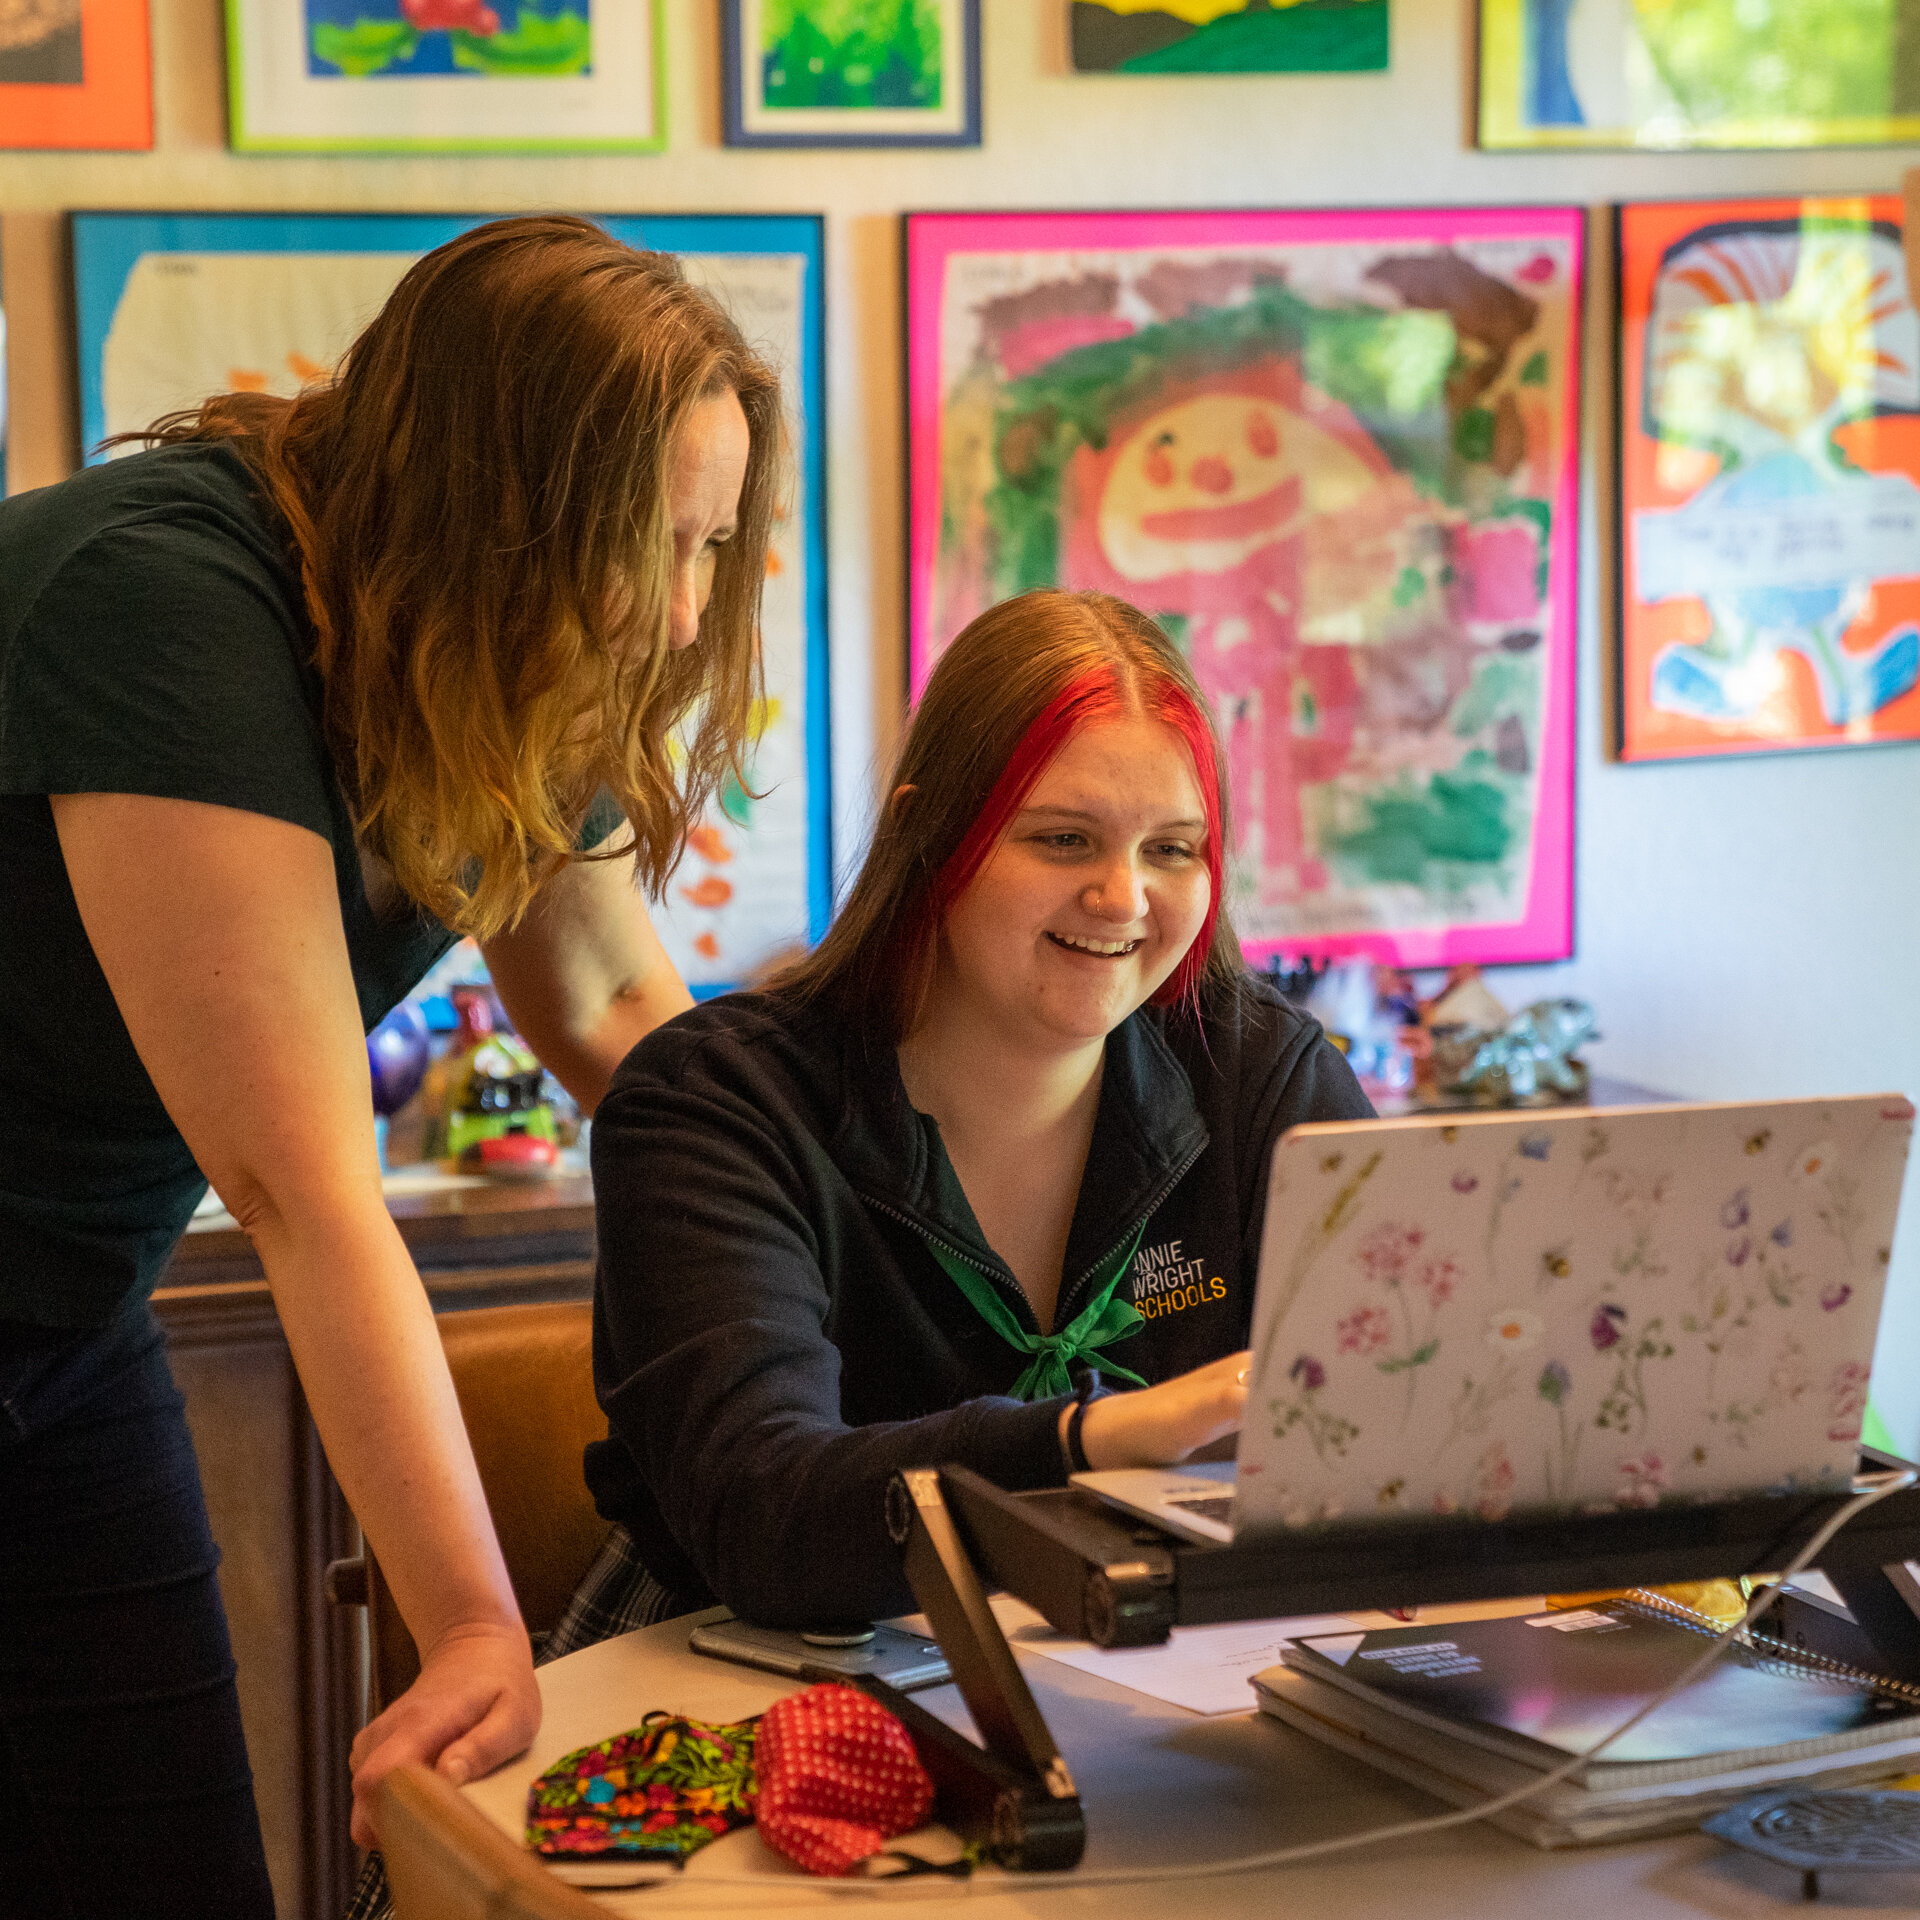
[1100,392,1375,580]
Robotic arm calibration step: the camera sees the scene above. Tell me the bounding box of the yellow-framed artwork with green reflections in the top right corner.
[1478,0,1920,148]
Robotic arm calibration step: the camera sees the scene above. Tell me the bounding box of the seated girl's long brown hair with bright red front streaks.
[776,588,1242,1043]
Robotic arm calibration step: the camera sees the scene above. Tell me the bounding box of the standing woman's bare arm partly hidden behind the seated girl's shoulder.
[482,828,693,1114]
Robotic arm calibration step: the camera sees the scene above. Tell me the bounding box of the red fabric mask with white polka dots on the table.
[755,1686,933,1874]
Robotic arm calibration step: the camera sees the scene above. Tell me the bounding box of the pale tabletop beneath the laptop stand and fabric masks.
[468,1615,1920,1920]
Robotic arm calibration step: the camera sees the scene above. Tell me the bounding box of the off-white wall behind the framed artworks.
[0,0,1920,1450]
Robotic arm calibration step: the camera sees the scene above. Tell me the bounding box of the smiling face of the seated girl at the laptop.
[933,718,1212,1052]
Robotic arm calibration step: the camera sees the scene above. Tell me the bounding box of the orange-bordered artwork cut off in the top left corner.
[0,0,154,150]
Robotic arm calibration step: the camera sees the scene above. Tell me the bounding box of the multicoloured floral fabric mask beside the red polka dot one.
[526,1713,756,1860]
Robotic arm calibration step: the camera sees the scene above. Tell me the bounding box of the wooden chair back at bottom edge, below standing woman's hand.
[380,1766,607,1920]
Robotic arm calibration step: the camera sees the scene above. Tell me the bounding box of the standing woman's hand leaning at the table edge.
[351,1626,540,1847]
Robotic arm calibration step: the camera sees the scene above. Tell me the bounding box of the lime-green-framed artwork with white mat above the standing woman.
[227,0,666,154]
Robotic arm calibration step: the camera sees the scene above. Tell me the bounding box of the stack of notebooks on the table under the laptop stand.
[1254,1594,1920,1847]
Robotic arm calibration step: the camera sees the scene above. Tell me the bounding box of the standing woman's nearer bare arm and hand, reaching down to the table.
[52,793,540,1843]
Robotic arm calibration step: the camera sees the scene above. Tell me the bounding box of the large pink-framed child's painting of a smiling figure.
[906,207,1584,966]
